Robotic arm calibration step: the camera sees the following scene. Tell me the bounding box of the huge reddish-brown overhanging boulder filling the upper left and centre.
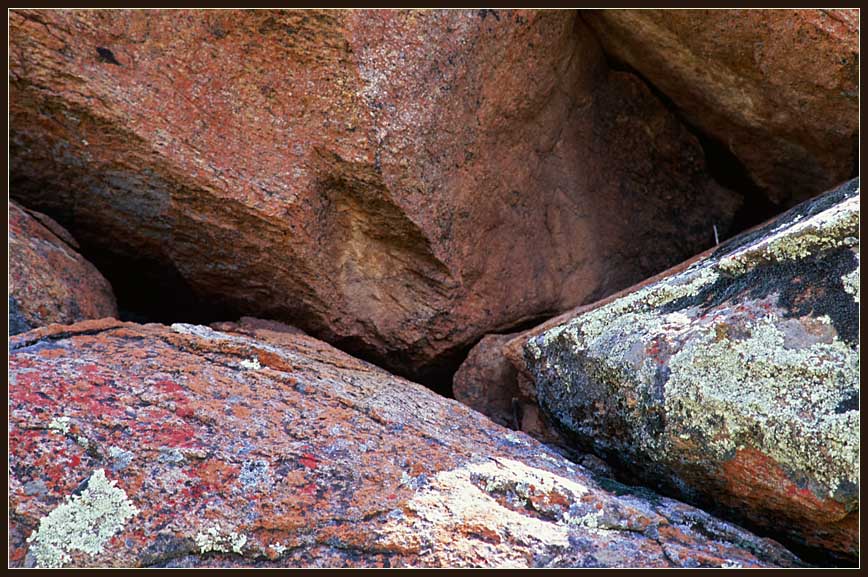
[10,10,737,382]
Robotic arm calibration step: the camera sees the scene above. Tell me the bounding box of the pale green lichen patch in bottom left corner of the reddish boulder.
[27,469,139,567]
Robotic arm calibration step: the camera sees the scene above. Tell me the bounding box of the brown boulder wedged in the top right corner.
[582,9,859,203]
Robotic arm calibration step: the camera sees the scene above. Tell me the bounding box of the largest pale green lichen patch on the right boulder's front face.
[666,318,859,497]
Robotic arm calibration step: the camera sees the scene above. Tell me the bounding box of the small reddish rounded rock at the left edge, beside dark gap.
[7,201,118,334]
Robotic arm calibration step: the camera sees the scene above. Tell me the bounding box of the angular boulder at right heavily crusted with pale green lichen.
[524,180,859,563]
